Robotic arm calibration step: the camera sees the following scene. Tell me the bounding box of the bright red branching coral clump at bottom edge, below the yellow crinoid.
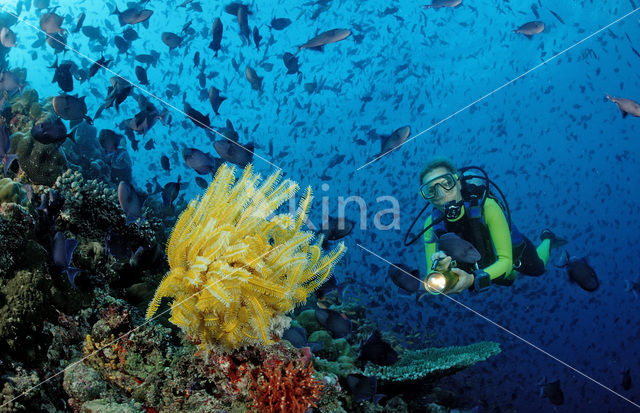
[251,359,323,413]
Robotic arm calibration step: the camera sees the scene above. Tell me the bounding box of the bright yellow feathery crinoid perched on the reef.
[147,165,345,350]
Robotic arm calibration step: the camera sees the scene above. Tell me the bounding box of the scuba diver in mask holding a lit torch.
[405,159,566,294]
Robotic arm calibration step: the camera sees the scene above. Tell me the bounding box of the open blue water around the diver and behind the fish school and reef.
[3,0,640,413]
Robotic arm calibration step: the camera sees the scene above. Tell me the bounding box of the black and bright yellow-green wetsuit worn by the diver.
[424,198,551,285]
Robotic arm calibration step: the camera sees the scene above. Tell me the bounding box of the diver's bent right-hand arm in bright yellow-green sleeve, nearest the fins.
[484,198,513,280]
